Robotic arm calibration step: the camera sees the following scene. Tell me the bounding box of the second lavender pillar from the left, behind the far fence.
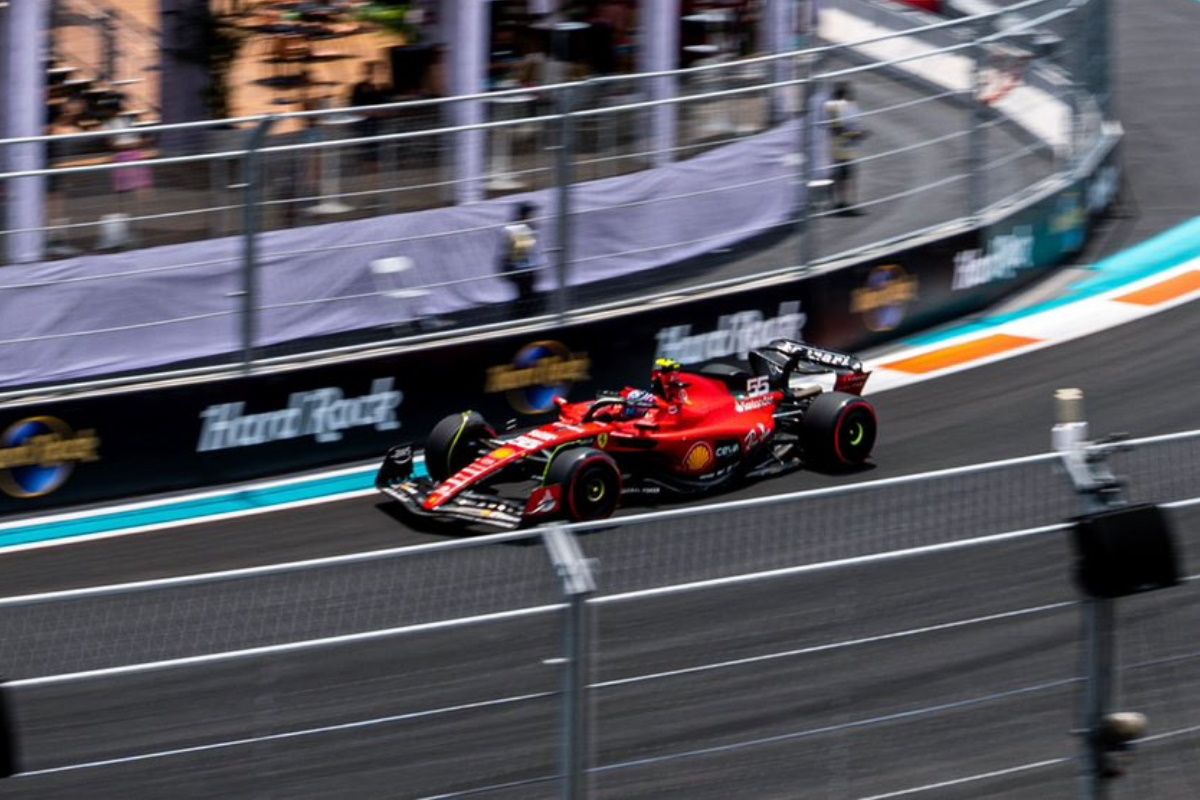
[442,0,492,203]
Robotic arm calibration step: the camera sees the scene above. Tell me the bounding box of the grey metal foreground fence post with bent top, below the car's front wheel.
[542,525,595,800]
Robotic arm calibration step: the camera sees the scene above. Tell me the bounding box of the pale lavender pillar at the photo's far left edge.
[0,0,49,264]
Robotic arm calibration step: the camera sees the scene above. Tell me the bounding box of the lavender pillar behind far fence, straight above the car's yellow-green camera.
[637,0,679,166]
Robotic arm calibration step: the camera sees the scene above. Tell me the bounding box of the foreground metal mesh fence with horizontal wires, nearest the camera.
[0,431,1200,799]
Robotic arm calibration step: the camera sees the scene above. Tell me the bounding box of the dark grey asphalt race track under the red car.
[0,0,1200,798]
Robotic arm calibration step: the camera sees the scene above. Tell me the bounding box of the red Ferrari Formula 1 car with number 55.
[376,339,876,529]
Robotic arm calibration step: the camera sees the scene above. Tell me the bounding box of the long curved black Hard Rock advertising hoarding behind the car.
[0,138,1116,517]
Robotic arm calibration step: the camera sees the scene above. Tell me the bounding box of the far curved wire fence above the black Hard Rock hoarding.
[0,0,1106,391]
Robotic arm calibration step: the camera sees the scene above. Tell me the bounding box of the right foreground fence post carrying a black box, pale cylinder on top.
[1052,389,1124,800]
